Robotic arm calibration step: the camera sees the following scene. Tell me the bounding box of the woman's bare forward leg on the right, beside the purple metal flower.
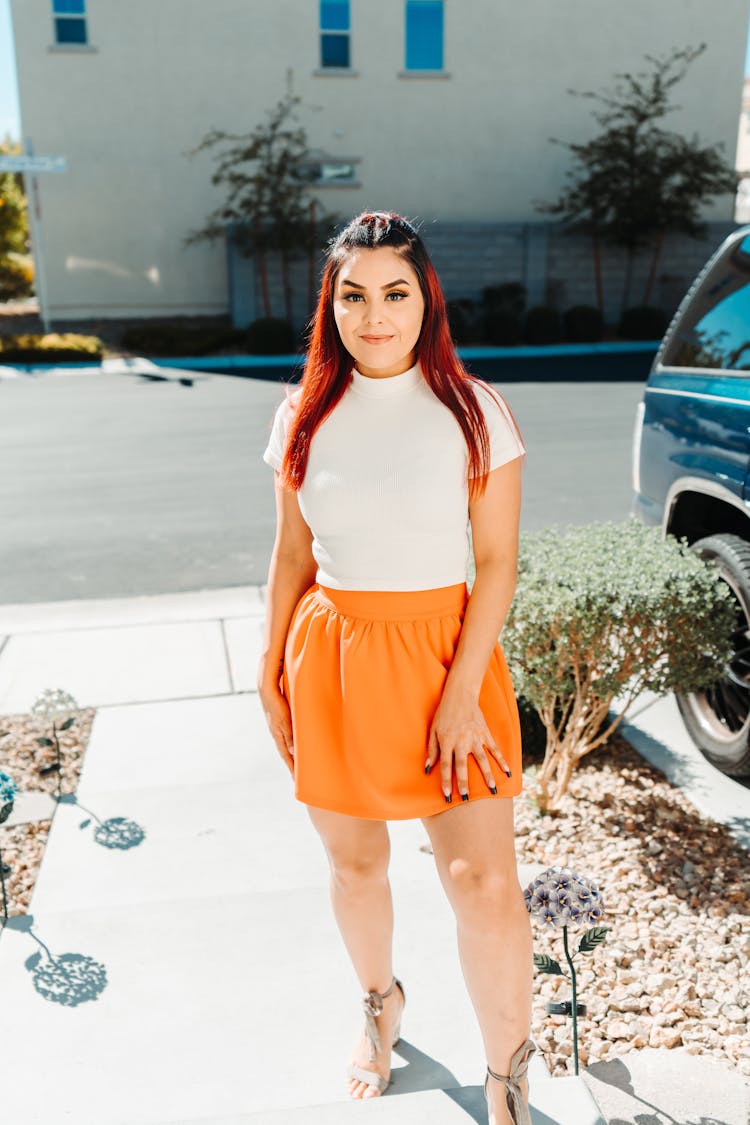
[422,797,533,1125]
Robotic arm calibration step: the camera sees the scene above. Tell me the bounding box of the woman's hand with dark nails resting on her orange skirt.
[425,681,510,800]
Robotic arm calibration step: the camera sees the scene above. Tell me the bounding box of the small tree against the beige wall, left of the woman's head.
[186,78,336,323]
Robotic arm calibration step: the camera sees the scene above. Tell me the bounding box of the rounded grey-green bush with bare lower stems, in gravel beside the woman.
[501,519,737,811]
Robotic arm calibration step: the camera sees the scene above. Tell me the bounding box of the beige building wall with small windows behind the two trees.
[11,0,750,318]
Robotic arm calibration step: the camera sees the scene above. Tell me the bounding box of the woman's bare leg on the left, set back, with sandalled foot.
[307,806,404,1098]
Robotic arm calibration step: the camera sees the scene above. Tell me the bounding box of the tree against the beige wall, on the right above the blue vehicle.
[535,43,738,311]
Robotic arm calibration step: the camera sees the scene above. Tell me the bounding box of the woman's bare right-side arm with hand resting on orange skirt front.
[426,457,522,794]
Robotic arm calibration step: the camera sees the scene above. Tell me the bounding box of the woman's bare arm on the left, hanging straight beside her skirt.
[256,470,317,770]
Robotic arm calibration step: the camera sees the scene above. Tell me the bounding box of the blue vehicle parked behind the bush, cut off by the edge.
[632,226,750,777]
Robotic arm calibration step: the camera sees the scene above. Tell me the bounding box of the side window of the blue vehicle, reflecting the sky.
[661,235,750,371]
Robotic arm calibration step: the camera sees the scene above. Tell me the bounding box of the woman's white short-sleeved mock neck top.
[263,363,526,591]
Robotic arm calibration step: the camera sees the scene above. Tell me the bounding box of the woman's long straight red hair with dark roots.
[273,212,521,498]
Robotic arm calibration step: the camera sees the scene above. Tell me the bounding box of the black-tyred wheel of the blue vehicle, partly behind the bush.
[675,534,750,777]
